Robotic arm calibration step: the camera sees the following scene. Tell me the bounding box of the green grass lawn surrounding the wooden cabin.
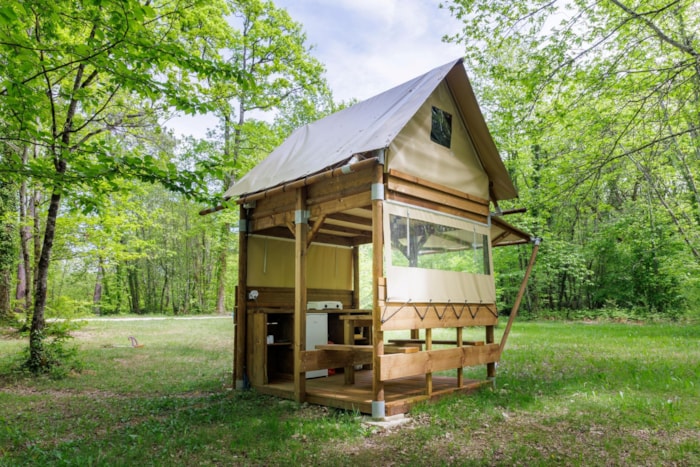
[0,318,700,466]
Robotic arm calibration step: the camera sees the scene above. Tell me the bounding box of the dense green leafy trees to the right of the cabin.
[446,0,700,316]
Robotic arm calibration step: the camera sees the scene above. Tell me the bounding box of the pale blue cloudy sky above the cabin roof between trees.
[169,0,463,138]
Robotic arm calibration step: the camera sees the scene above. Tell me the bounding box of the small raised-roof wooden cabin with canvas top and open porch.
[216,60,536,418]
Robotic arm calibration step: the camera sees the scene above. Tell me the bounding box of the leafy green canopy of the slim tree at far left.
[0,0,237,203]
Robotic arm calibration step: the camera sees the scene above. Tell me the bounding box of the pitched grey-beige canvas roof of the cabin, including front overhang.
[224,59,517,200]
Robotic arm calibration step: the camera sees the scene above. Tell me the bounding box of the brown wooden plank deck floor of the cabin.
[256,370,491,416]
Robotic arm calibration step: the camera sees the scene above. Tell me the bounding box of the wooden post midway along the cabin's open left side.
[293,187,309,403]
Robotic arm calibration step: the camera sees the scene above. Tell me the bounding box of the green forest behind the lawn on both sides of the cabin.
[0,0,700,365]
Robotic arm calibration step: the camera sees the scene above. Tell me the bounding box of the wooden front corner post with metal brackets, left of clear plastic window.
[372,164,386,418]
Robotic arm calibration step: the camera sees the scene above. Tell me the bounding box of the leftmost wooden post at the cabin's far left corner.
[233,205,248,389]
